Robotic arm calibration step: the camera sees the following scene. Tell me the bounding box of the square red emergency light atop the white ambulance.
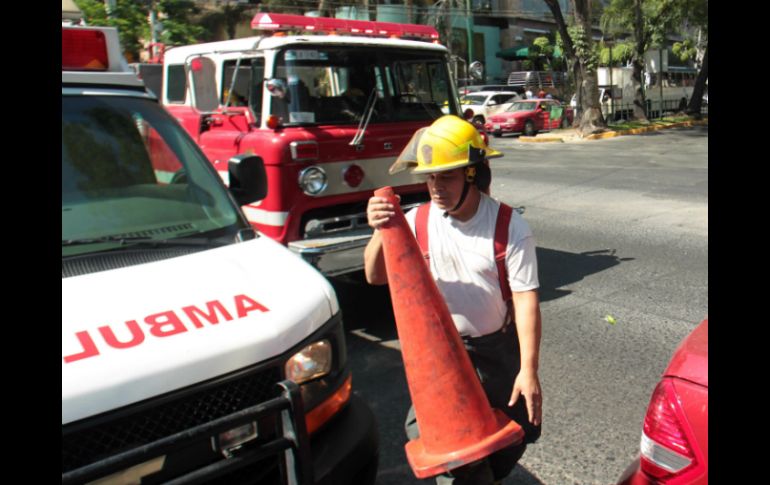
[61,29,110,71]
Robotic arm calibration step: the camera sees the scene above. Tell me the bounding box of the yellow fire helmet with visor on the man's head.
[388,115,503,174]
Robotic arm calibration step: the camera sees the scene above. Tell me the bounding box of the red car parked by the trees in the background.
[484,99,574,136]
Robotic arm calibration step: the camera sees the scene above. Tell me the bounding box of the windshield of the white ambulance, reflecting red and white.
[62,95,242,256]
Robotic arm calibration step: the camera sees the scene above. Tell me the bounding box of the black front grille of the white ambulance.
[62,366,280,472]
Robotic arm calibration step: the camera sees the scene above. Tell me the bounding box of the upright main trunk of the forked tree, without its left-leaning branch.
[572,0,607,137]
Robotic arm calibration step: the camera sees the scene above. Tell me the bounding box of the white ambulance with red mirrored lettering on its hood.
[62,22,378,485]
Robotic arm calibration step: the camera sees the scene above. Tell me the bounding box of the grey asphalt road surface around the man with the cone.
[333,127,708,485]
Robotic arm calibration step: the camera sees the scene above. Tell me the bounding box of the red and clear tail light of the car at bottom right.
[641,379,695,478]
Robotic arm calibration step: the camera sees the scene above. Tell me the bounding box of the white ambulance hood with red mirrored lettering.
[62,237,339,424]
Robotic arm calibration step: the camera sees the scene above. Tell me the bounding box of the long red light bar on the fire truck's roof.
[251,13,439,40]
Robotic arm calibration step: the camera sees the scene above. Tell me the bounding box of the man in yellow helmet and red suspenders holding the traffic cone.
[364,115,542,485]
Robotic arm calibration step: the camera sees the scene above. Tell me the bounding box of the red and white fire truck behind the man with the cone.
[162,13,460,276]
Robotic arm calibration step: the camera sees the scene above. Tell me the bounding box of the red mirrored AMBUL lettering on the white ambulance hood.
[64,295,270,364]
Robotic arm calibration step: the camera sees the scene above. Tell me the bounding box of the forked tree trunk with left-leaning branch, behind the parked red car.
[543,0,607,136]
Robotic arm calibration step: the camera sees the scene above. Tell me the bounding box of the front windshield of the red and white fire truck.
[269,45,458,126]
